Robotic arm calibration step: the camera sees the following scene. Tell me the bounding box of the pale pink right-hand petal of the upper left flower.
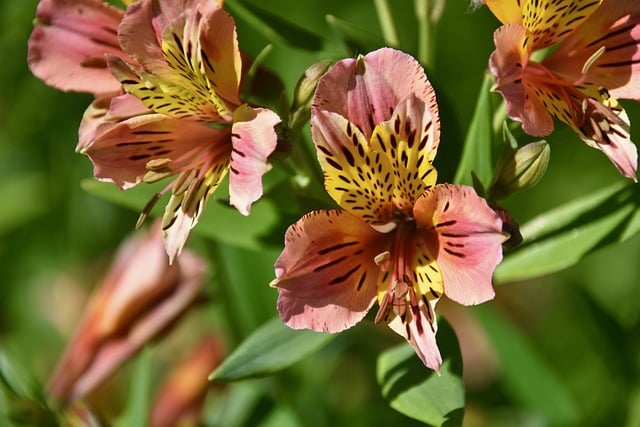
[229,104,280,215]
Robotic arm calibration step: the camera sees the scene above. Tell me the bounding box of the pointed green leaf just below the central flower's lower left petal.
[209,317,335,381]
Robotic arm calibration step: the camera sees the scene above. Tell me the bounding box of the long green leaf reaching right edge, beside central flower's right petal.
[494,182,640,283]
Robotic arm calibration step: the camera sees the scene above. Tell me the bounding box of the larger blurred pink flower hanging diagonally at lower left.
[49,224,205,402]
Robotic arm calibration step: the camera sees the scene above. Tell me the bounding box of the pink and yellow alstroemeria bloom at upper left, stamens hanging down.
[79,0,280,259]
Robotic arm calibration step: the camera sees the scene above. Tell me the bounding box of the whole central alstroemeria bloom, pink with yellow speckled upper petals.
[272,48,504,370]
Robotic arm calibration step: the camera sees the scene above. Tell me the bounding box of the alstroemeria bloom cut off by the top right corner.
[485,0,640,180]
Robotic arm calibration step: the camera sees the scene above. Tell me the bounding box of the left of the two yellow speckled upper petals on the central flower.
[311,110,394,224]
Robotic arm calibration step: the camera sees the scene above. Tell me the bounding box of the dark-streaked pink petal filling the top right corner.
[544,0,640,100]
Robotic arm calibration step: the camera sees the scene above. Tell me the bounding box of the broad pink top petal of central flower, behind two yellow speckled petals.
[312,48,437,139]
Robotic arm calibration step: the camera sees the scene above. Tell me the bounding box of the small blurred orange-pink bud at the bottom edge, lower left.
[149,336,222,427]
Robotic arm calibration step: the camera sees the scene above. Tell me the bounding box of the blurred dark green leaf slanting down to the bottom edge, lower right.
[474,305,578,425]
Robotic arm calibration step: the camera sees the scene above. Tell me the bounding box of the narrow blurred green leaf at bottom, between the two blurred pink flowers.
[114,348,154,427]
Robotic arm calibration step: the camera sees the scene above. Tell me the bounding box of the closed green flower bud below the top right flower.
[488,141,550,200]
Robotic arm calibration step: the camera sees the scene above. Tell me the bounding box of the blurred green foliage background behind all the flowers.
[0,0,640,427]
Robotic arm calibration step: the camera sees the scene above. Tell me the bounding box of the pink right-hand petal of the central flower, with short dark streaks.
[414,184,505,305]
